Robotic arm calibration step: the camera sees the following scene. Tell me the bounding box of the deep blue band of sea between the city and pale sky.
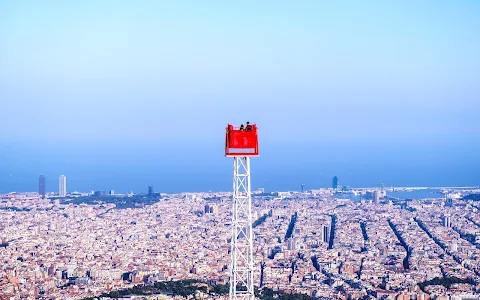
[0,131,480,193]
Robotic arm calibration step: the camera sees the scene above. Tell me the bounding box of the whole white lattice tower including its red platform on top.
[225,122,258,300]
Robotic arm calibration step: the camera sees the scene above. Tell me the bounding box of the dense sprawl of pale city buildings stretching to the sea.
[0,175,480,299]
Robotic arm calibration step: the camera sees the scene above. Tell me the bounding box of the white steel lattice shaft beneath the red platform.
[230,156,254,300]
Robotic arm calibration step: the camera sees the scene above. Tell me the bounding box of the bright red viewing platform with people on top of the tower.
[225,124,258,157]
